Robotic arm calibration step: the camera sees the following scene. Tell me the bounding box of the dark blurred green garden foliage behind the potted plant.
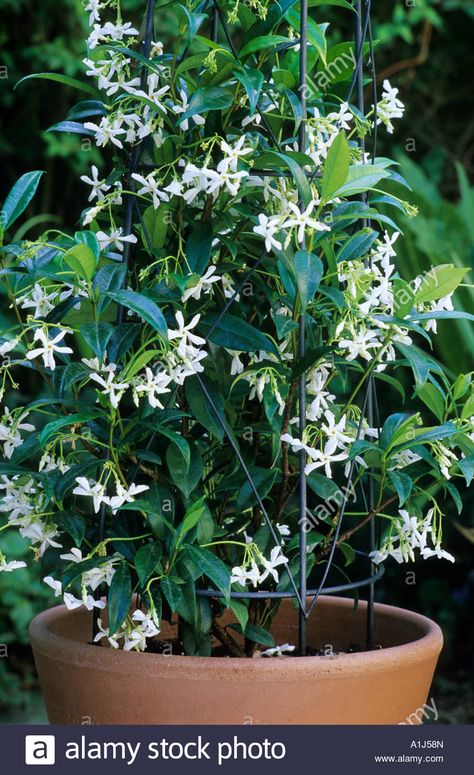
[0,0,474,723]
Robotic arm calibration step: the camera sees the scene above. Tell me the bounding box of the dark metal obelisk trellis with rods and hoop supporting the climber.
[103,0,383,655]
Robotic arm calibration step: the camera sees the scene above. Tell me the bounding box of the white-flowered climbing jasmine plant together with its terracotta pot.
[0,0,474,724]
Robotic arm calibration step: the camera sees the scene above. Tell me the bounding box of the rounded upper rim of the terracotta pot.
[29,595,443,675]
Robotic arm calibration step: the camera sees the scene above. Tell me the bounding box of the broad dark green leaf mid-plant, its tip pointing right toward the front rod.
[200,314,280,355]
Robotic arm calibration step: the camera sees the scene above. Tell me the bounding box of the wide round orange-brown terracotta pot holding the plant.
[30,597,443,724]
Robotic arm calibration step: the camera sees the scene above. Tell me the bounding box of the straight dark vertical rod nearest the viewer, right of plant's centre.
[298,0,308,656]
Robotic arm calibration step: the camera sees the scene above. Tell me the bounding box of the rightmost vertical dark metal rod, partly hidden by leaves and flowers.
[355,0,375,650]
